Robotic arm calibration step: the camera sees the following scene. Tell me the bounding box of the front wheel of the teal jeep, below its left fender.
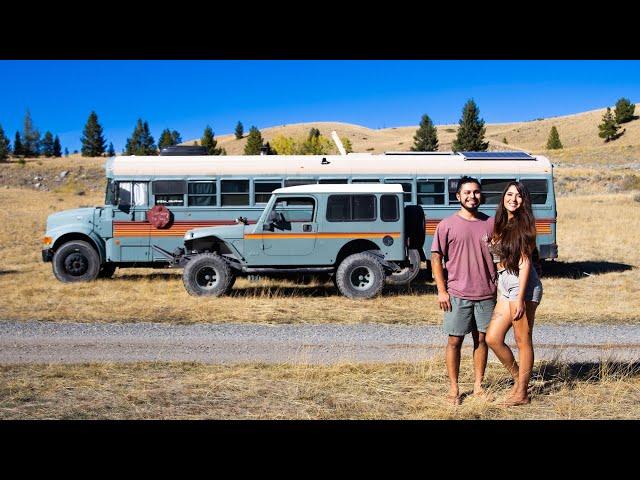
[182,253,235,297]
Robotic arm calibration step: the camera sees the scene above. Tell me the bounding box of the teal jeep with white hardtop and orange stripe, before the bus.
[159,184,425,298]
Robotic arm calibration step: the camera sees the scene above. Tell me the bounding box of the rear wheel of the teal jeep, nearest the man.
[335,253,385,299]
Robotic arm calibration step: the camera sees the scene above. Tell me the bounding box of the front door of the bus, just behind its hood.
[113,181,150,262]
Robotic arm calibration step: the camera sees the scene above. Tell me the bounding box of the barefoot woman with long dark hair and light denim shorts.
[486,182,542,406]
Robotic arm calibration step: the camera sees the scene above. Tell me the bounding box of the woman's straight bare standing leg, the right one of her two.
[507,302,538,405]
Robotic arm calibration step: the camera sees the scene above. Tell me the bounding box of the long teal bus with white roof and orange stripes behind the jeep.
[43,152,557,282]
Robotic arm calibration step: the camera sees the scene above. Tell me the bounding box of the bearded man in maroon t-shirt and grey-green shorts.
[431,176,496,405]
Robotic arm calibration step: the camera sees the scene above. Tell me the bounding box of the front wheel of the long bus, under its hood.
[51,240,100,283]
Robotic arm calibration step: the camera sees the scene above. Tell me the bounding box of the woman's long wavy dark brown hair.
[493,182,537,274]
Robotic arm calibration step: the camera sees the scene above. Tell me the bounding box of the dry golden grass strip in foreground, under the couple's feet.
[0,359,640,419]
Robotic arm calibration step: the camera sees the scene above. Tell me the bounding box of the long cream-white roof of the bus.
[105,152,552,177]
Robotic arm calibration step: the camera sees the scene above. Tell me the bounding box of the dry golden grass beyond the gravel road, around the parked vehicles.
[0,188,640,324]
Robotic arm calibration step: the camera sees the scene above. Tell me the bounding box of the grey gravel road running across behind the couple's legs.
[0,321,640,365]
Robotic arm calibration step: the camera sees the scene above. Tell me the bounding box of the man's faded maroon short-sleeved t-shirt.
[431,213,496,300]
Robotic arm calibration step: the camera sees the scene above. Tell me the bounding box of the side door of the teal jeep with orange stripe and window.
[262,196,318,256]
